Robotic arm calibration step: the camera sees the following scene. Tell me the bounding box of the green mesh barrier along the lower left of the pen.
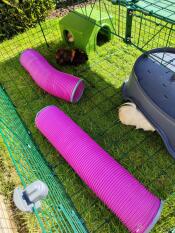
[0,87,87,233]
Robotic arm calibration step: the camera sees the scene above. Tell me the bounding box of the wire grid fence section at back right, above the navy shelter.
[70,0,175,72]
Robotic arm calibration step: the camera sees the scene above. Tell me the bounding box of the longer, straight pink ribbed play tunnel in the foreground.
[35,106,162,233]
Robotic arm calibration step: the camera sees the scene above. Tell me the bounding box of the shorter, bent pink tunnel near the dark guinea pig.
[20,49,84,102]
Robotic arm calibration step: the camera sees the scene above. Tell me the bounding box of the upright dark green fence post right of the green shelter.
[125,7,133,44]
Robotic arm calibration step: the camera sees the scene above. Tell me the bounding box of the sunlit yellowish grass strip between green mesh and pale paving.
[0,136,40,233]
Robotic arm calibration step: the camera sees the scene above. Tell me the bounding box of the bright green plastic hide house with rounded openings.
[59,7,114,53]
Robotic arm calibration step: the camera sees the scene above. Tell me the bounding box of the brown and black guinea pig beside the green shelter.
[56,48,88,66]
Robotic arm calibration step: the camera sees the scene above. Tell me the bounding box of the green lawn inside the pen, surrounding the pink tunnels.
[0,13,175,233]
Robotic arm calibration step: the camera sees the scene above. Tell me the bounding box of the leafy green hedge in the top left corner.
[0,0,55,41]
